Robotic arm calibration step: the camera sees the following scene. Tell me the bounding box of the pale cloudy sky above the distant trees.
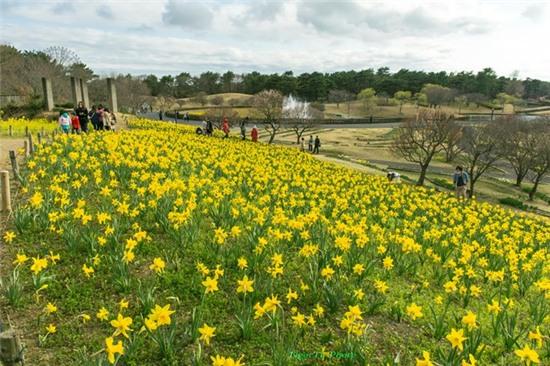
[0,0,550,80]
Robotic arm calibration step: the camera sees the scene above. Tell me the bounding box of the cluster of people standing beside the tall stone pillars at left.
[58,102,117,134]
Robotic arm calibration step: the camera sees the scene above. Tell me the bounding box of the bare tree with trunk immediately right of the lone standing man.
[459,124,501,197]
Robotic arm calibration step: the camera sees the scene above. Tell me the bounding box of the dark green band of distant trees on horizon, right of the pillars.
[144,67,550,102]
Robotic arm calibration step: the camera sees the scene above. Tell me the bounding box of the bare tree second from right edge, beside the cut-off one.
[497,118,534,187]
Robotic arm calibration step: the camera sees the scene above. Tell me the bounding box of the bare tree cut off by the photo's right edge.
[529,122,550,201]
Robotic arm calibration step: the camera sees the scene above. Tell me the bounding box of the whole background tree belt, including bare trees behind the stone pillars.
[0,45,550,115]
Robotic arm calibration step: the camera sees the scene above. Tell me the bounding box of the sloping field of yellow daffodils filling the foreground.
[0,120,550,366]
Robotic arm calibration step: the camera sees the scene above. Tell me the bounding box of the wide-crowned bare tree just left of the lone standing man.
[391,110,451,185]
